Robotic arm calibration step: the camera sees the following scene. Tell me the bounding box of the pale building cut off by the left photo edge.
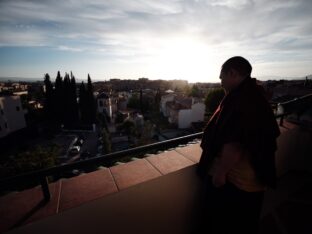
[0,95,26,138]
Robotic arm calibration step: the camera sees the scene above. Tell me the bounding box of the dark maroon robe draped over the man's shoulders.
[198,78,280,187]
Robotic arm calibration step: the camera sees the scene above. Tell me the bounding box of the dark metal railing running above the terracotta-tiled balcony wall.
[0,94,312,202]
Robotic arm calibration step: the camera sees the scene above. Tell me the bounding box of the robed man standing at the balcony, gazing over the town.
[198,57,279,234]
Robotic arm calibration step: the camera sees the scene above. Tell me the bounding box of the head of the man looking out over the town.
[220,56,252,92]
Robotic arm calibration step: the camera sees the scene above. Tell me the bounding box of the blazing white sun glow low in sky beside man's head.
[151,38,219,82]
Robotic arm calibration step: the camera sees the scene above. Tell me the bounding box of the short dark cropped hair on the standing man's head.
[221,56,252,77]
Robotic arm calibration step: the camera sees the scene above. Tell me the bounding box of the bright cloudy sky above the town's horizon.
[0,0,312,82]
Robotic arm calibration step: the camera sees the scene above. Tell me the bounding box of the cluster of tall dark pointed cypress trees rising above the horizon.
[44,71,96,127]
